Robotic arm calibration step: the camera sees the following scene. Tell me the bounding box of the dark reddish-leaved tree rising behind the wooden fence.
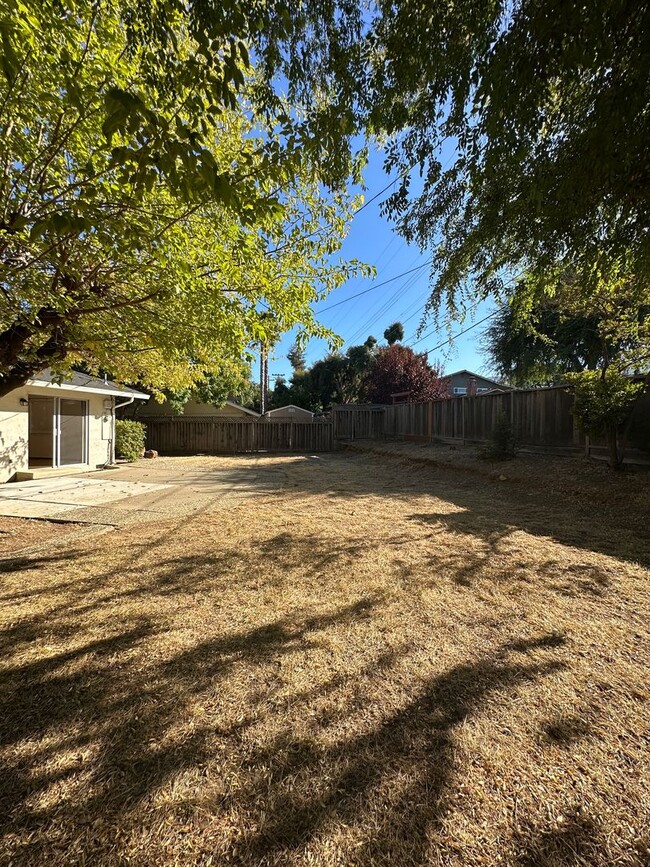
[368,343,447,403]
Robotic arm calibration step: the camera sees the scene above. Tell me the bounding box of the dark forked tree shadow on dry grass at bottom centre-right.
[225,642,564,865]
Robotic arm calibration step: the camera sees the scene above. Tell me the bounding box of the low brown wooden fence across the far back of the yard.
[138,416,333,455]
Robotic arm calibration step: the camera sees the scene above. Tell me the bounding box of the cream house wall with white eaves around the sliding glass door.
[0,385,114,483]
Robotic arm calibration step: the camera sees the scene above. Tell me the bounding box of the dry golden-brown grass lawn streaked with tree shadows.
[0,455,650,867]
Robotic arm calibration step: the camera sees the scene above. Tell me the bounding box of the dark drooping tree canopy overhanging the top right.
[116,0,650,313]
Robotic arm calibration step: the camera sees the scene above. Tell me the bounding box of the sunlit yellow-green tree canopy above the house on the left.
[0,0,364,393]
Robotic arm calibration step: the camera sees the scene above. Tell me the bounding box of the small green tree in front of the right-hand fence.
[567,368,645,470]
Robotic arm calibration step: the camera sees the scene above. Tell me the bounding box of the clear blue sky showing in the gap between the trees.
[264,145,494,388]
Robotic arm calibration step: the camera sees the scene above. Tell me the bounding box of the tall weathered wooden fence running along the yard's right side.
[332,386,650,452]
